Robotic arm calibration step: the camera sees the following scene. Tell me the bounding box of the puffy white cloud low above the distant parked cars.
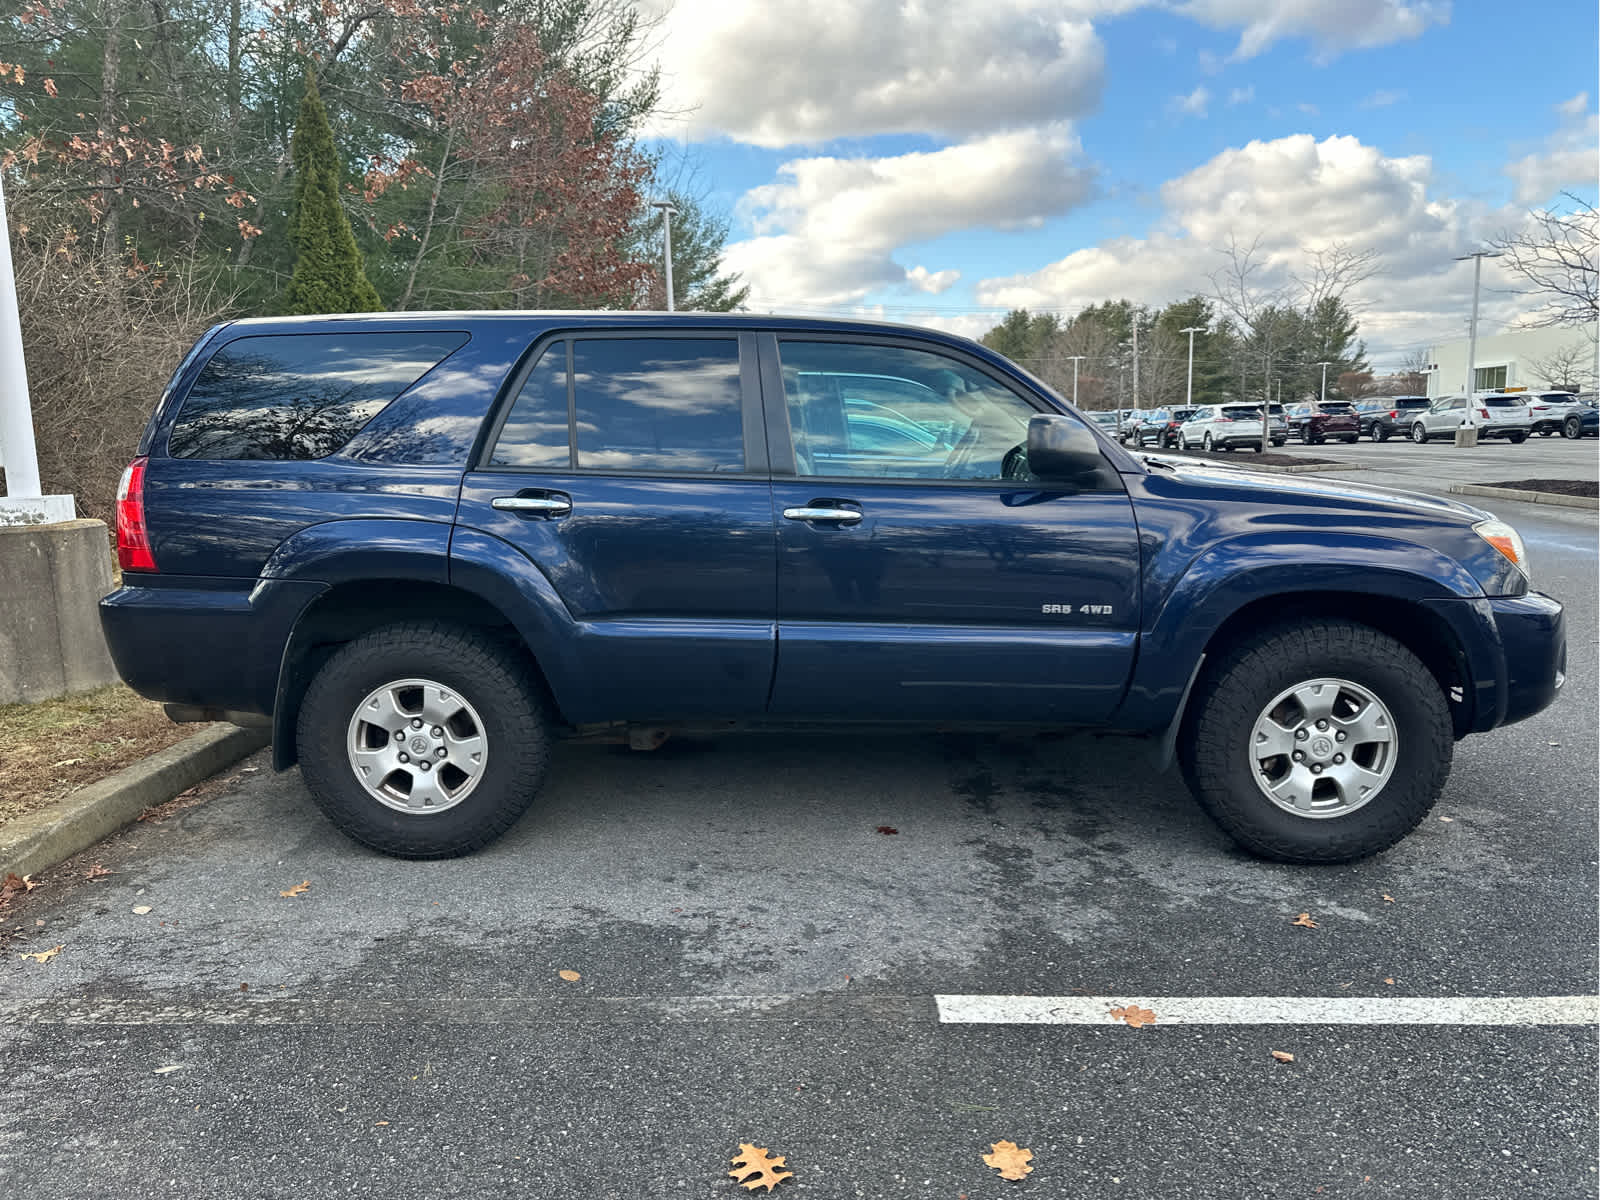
[976,134,1526,354]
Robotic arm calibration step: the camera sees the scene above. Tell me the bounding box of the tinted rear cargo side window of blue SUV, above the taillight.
[168,333,467,459]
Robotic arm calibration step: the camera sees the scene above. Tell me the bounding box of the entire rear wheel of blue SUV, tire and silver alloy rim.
[296,622,550,858]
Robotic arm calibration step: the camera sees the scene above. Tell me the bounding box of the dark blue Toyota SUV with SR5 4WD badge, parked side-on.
[102,314,1565,862]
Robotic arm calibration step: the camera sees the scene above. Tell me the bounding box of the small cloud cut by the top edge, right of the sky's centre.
[1178,0,1450,59]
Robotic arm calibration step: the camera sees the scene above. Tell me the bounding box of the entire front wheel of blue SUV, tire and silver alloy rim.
[1182,621,1454,862]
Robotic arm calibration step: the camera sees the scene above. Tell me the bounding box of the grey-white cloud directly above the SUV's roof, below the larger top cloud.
[723,125,1093,309]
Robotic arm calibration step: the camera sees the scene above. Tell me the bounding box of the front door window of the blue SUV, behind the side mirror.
[779,341,1037,480]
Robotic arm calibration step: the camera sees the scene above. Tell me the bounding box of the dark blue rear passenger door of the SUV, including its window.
[458,326,776,720]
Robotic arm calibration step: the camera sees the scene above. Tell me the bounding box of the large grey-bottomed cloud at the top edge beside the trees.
[654,0,1107,147]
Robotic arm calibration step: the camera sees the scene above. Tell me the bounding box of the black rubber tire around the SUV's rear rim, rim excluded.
[296,621,550,859]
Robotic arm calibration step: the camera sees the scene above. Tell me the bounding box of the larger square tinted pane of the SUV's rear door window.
[573,338,744,472]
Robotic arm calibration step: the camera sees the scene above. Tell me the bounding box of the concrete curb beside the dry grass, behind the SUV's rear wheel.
[0,725,270,878]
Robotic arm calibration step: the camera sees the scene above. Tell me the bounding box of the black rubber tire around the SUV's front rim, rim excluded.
[1179,621,1454,862]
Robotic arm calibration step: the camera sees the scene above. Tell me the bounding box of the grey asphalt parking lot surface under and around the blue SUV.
[0,454,1600,1200]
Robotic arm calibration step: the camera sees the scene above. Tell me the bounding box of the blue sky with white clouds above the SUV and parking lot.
[646,0,1600,368]
